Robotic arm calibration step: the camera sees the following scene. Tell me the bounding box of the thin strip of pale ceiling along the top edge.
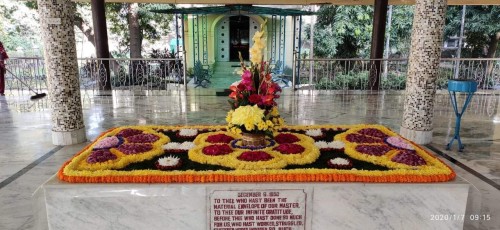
[94,0,500,5]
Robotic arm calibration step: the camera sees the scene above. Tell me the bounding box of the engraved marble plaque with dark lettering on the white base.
[208,189,307,230]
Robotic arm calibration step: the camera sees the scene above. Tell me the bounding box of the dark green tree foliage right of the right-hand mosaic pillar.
[445,6,500,58]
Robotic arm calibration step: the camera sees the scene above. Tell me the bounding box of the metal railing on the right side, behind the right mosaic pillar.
[290,58,500,90]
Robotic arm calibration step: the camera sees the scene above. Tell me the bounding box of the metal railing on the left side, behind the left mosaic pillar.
[5,58,188,97]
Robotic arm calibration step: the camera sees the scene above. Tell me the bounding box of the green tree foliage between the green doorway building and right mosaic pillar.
[312,5,413,58]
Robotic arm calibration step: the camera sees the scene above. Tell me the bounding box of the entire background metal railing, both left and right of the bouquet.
[6,58,500,94]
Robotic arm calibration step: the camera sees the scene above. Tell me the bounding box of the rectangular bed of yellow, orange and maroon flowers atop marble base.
[58,124,456,183]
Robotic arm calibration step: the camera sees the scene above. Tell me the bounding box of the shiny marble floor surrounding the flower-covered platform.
[0,89,500,229]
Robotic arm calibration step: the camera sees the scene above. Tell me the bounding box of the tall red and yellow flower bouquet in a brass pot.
[226,20,284,145]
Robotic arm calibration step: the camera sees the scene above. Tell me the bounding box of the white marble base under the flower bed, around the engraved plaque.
[34,178,469,230]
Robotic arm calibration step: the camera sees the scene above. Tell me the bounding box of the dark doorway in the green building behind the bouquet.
[229,15,250,61]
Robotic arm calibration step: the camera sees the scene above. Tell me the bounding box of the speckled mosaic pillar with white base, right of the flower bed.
[400,0,447,144]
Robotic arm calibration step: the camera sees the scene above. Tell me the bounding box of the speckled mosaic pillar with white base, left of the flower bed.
[38,0,86,145]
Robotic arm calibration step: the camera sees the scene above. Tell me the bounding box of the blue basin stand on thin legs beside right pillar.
[446,80,477,152]
